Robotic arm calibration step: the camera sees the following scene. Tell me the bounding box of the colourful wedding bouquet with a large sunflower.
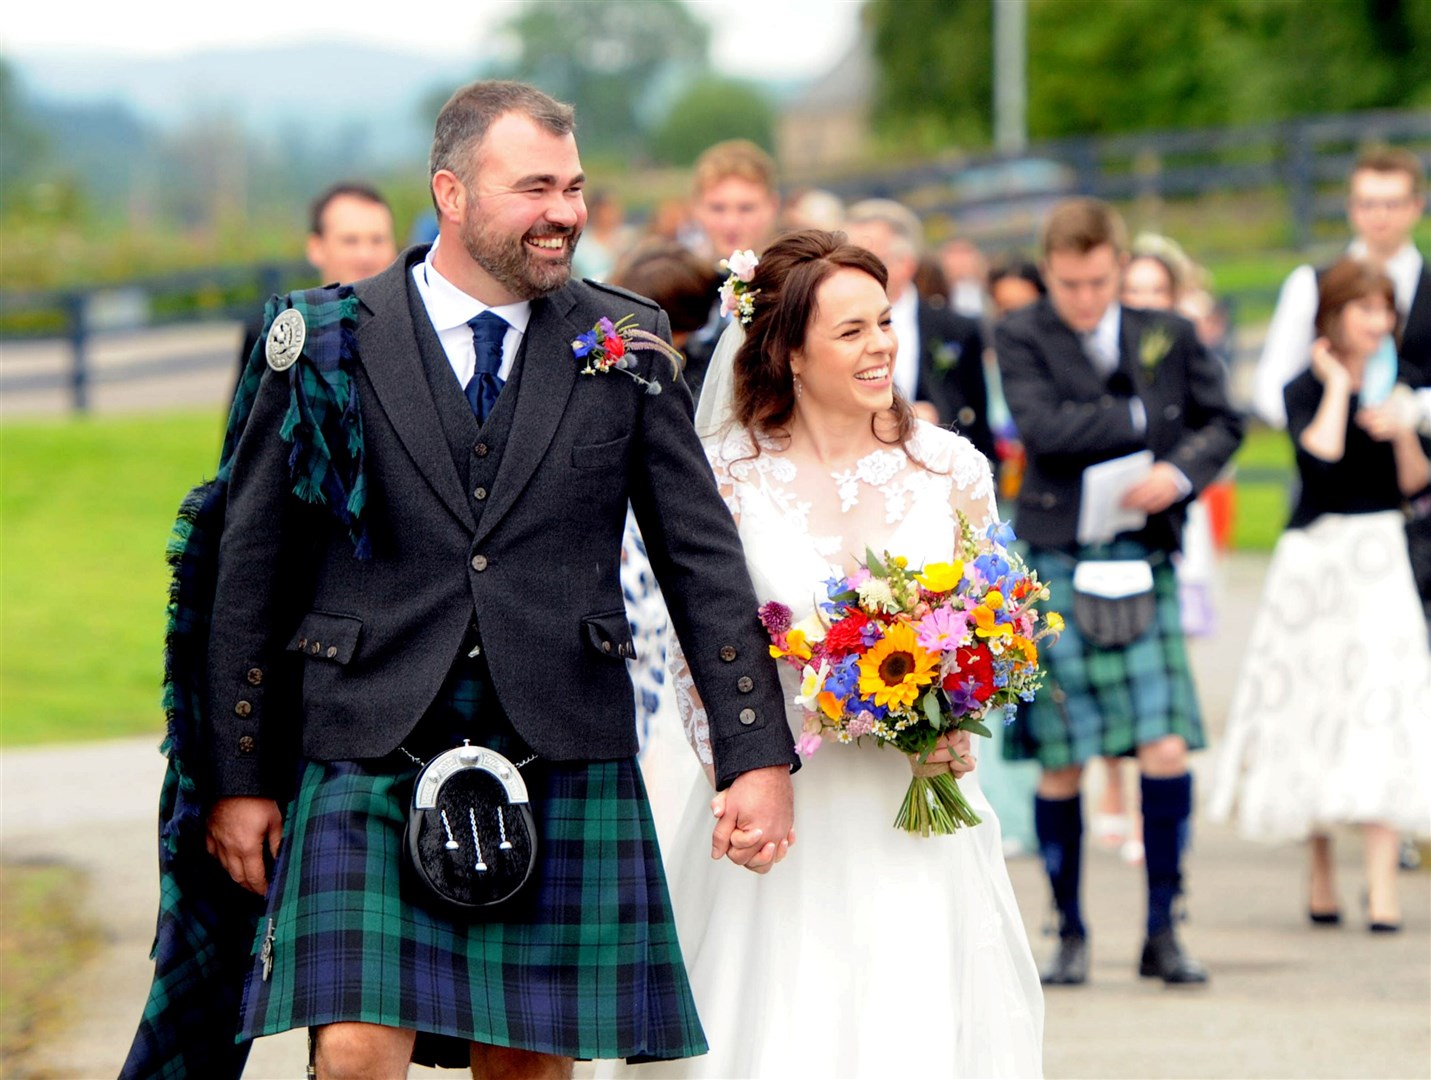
[760,514,1063,837]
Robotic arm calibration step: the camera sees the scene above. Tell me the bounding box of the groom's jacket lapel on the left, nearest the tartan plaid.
[353,247,477,529]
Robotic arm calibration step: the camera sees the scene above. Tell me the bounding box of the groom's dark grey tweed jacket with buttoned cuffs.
[206,247,796,795]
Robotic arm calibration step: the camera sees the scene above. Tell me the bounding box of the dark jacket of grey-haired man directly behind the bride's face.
[917,296,995,462]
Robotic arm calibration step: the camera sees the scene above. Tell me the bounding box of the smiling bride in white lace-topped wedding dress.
[603,230,1043,1080]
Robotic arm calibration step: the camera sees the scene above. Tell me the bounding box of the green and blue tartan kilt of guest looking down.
[1003,541,1206,770]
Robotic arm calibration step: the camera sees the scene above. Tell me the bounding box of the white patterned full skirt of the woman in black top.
[1208,512,1431,840]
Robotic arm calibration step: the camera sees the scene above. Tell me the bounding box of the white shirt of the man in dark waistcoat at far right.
[1252,240,1422,428]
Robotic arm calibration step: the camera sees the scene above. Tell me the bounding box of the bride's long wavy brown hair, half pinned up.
[731,229,914,453]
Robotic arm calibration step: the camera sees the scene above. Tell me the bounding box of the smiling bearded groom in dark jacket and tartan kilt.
[203,82,796,1077]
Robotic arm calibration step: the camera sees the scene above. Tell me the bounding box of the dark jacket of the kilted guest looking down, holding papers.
[995,298,1242,551]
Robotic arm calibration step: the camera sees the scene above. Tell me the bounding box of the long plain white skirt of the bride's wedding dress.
[595,729,1043,1080]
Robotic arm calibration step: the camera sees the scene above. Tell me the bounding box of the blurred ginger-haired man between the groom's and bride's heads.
[685,139,780,396]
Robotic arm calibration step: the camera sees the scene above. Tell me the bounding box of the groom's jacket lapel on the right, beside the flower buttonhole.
[477,289,578,539]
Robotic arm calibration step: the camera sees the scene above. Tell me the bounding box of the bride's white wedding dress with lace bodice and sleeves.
[620,423,1043,1080]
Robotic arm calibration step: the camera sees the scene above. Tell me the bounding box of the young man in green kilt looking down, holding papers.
[995,199,1242,984]
